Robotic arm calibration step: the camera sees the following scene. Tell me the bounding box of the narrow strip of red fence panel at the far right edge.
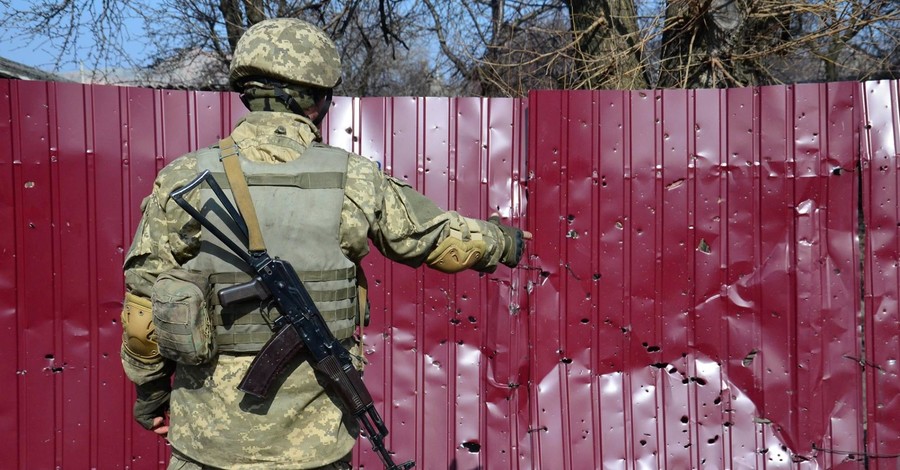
[860,81,900,469]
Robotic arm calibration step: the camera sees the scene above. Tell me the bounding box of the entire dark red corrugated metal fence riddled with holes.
[0,80,900,470]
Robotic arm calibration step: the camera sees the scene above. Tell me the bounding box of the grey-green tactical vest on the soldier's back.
[185,144,359,353]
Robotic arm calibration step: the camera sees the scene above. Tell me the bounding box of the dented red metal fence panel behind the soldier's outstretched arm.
[325,98,529,469]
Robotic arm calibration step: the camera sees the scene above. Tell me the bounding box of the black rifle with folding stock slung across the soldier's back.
[171,170,415,470]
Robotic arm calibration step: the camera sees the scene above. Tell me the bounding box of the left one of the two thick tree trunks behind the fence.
[568,0,649,89]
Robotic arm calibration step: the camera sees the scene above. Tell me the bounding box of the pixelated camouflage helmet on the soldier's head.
[228,18,341,91]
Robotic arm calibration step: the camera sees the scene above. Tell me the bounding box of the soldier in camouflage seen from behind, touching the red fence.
[121,18,531,470]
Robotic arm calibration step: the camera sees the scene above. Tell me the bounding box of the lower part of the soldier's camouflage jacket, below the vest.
[169,342,358,470]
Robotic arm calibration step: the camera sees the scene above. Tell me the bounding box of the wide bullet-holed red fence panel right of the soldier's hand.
[527,83,864,468]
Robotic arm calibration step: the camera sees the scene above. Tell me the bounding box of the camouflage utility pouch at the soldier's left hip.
[151,268,216,365]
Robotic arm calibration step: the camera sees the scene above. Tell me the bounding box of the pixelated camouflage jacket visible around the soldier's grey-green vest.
[123,112,505,470]
